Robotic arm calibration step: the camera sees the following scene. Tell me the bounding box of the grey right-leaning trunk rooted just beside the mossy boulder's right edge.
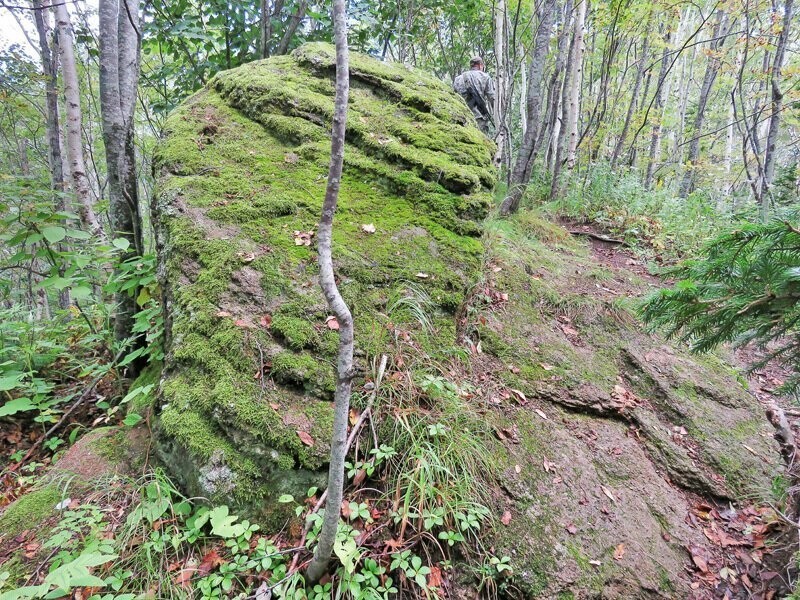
[500,0,556,216]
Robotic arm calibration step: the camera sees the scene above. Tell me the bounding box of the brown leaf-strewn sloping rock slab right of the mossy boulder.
[473,214,785,598]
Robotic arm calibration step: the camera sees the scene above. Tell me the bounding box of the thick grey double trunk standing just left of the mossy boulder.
[98,0,143,342]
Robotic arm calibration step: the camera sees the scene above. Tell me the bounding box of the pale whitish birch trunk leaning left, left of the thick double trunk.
[54,2,106,240]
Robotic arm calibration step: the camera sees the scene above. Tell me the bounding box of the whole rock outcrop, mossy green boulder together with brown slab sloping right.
[153,44,779,598]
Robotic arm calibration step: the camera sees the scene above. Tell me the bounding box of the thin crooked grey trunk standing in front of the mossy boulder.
[306,0,353,582]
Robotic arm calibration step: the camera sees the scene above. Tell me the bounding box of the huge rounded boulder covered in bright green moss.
[153,44,495,517]
